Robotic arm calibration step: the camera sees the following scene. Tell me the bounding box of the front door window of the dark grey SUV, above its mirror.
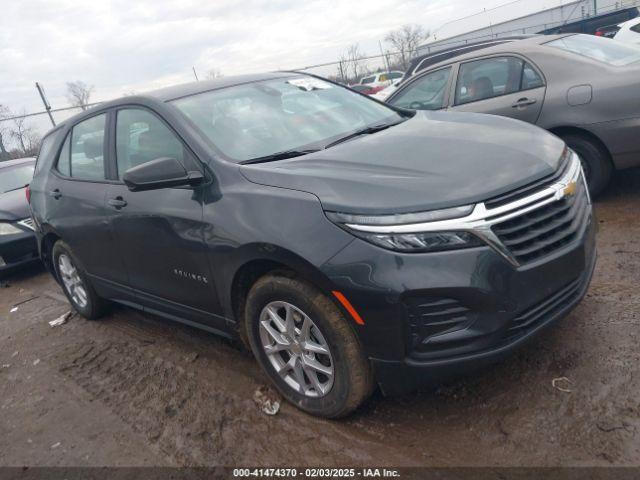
[116,108,186,179]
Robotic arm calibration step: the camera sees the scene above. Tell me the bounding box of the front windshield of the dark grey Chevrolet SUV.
[171,76,402,162]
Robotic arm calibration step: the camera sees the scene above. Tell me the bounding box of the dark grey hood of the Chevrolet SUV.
[240,112,564,214]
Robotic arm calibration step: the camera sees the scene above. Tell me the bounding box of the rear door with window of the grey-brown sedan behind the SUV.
[451,55,546,124]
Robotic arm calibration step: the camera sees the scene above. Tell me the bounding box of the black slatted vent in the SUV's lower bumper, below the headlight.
[405,297,470,350]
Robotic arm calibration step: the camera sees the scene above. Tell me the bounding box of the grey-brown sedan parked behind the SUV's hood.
[387,35,640,194]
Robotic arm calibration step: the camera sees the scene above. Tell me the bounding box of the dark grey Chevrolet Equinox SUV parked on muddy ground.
[31,72,596,417]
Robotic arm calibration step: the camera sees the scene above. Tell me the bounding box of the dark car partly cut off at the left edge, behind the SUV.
[0,158,39,274]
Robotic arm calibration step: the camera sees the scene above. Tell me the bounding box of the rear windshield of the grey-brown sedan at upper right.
[547,35,640,67]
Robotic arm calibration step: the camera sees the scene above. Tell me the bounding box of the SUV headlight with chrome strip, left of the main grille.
[327,209,486,253]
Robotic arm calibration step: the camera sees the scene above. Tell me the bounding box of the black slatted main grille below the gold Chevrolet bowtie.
[491,178,590,265]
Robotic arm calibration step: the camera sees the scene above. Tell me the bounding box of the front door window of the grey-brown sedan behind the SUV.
[390,67,451,110]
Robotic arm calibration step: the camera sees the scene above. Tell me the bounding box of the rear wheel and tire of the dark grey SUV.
[51,240,107,320]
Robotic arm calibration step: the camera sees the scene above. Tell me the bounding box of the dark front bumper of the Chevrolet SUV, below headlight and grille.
[323,208,596,394]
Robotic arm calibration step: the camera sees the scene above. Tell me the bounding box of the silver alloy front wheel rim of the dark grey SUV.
[259,301,334,398]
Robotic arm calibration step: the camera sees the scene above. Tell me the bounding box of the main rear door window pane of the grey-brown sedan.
[456,57,524,105]
